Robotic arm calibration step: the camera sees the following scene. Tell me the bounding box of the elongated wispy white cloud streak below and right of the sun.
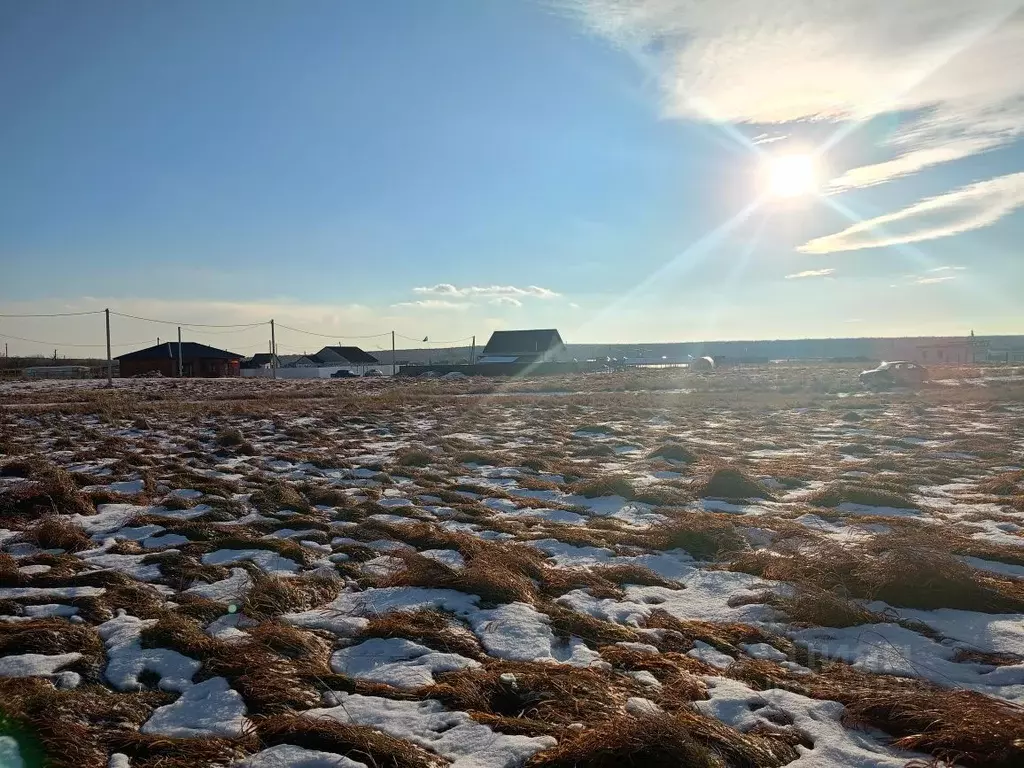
[798,173,1024,253]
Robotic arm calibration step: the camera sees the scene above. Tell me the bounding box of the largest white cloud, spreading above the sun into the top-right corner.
[562,0,1024,188]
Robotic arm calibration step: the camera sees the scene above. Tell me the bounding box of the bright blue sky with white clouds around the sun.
[0,0,1024,355]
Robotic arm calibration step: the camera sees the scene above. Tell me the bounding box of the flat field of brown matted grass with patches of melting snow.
[0,366,1024,768]
